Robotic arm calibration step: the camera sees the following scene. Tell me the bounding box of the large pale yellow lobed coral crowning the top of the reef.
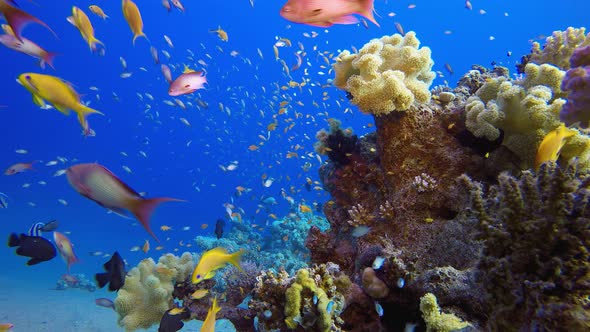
[333,31,436,115]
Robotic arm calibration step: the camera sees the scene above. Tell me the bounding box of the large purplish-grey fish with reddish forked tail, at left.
[66,164,183,243]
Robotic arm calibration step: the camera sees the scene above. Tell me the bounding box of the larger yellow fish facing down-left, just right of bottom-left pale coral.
[191,247,246,284]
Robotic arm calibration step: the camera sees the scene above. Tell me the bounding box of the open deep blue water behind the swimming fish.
[0,0,590,326]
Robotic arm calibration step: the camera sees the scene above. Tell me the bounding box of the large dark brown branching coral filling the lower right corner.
[462,163,590,331]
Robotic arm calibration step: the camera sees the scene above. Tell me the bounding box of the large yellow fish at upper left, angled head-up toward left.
[18,73,104,132]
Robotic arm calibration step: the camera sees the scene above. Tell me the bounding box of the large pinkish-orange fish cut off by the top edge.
[281,0,379,27]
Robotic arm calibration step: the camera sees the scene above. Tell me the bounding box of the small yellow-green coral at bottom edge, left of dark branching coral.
[420,293,470,332]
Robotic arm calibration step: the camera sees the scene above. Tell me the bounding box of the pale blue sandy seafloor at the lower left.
[0,271,235,332]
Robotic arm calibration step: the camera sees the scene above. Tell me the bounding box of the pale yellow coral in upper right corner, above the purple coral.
[529,27,590,70]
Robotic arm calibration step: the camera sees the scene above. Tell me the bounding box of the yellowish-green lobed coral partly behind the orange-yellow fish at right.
[465,63,590,168]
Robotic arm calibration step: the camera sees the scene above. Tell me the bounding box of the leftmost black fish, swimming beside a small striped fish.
[8,233,57,265]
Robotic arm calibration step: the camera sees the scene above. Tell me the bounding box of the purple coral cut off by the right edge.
[560,43,590,128]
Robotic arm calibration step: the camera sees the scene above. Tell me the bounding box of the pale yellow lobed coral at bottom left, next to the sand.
[115,253,194,331]
